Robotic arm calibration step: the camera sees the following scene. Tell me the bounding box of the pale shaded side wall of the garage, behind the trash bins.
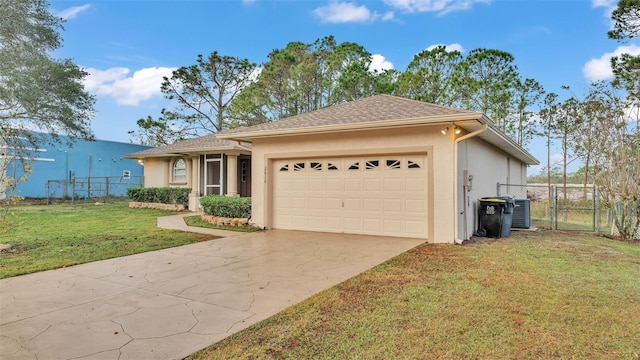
[457,138,527,240]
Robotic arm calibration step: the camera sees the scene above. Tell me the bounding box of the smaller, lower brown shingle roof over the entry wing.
[125,134,251,158]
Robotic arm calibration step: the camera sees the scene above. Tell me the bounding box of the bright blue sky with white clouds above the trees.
[50,0,640,173]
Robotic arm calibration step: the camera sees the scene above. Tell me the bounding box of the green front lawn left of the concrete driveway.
[0,202,214,278]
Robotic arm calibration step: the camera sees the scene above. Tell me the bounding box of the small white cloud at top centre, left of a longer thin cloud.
[313,1,394,24]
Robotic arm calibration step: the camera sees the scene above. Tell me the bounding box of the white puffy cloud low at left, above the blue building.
[85,67,176,106]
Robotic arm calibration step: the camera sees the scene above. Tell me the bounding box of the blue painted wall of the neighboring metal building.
[8,137,149,198]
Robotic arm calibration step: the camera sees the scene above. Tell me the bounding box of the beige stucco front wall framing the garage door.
[252,126,456,243]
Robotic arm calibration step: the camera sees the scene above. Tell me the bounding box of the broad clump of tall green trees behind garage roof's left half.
[229,36,390,126]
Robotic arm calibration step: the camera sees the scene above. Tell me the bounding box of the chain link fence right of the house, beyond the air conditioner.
[497,184,612,232]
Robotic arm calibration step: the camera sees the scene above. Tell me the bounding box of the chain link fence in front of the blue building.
[45,176,144,204]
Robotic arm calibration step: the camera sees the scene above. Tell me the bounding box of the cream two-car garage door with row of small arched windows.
[272,155,427,238]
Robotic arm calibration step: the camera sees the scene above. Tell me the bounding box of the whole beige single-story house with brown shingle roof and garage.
[129,95,538,243]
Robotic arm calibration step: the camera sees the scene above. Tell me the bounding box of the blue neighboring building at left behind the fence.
[0,134,149,198]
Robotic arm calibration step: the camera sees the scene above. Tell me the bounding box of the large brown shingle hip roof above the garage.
[223,95,473,135]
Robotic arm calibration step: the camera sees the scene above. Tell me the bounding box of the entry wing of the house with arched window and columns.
[125,134,251,211]
